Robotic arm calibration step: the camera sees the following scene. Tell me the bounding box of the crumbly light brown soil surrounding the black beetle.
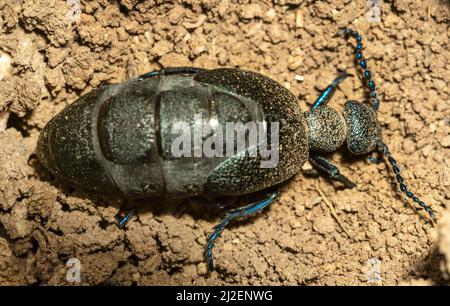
[0,0,450,285]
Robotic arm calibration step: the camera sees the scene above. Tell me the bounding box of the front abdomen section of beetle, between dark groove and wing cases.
[157,76,264,197]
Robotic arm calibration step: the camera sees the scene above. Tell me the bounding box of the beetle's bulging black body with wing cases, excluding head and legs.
[37,68,308,198]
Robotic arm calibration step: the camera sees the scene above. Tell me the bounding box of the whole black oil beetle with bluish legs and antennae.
[37,29,435,271]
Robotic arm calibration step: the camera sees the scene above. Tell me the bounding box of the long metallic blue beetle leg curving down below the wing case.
[205,191,278,273]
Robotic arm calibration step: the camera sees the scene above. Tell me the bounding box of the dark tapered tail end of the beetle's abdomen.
[37,88,124,194]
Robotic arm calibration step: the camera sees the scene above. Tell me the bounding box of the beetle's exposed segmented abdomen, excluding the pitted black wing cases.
[37,69,270,198]
